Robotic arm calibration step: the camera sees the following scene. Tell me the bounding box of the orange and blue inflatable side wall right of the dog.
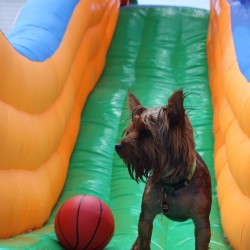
[207,0,250,250]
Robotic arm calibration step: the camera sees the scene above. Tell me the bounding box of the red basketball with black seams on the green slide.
[54,195,114,250]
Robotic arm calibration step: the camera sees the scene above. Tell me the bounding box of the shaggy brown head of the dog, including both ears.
[115,90,195,182]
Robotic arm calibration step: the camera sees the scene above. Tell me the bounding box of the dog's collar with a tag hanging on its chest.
[161,159,196,213]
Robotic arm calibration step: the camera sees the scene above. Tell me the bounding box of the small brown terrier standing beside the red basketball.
[115,90,212,250]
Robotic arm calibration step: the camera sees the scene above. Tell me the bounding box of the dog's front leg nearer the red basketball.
[132,184,161,250]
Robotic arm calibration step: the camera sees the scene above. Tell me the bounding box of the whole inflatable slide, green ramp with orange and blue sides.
[0,0,250,250]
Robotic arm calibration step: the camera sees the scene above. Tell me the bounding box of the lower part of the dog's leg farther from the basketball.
[194,217,211,250]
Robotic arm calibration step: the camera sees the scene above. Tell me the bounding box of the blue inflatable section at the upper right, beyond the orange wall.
[229,0,250,82]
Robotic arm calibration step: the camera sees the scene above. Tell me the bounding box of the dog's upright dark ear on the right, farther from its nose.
[167,90,185,126]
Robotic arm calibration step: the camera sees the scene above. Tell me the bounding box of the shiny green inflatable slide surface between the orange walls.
[0,6,230,250]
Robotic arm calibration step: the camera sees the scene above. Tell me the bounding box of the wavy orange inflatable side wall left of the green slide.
[0,0,119,239]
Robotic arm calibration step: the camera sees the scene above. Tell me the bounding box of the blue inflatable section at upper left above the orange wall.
[7,0,79,62]
